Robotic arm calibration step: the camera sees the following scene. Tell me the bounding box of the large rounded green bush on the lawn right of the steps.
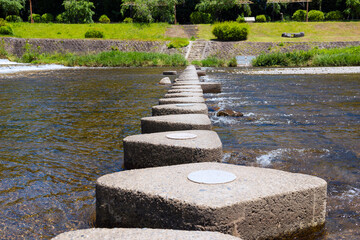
[212,22,249,41]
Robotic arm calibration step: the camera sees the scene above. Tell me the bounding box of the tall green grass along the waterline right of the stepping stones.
[253,46,360,67]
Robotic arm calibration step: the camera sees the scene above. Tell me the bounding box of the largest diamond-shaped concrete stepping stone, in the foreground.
[96,163,327,239]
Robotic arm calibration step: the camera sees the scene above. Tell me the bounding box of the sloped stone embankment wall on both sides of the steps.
[1,38,360,59]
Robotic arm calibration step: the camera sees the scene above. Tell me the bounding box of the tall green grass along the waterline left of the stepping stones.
[13,51,187,67]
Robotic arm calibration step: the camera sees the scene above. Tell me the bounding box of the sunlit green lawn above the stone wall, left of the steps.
[4,22,176,41]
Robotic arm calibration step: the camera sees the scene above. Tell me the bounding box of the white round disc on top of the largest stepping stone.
[188,169,236,184]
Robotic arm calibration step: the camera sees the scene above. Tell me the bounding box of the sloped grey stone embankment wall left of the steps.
[0,38,187,56]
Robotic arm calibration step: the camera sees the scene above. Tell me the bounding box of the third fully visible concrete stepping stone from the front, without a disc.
[141,114,211,133]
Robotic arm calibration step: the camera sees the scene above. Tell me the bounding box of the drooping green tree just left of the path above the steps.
[121,0,183,22]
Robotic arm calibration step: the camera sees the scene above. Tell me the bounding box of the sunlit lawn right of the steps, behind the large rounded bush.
[198,22,360,42]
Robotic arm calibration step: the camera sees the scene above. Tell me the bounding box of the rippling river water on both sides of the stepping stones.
[0,68,360,239]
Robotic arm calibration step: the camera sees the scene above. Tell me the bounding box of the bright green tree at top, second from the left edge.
[62,0,95,23]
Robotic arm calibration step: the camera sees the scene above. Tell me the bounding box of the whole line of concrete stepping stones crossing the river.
[54,66,327,240]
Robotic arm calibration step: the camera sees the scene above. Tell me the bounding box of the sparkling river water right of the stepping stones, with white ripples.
[206,72,360,239]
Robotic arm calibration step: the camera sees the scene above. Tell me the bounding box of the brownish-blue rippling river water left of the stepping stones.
[0,68,170,239]
